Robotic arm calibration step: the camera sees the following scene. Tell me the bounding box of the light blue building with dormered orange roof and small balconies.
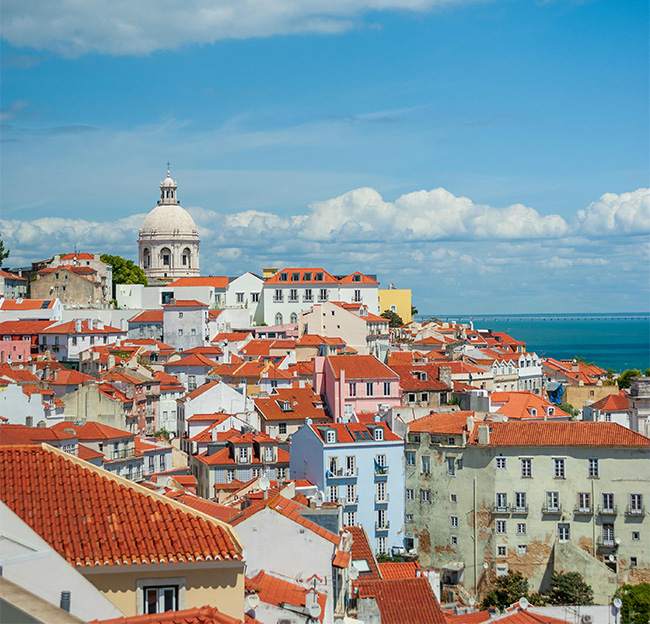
[291,422,404,553]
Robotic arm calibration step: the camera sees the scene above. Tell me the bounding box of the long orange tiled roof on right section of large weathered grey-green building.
[472,420,650,447]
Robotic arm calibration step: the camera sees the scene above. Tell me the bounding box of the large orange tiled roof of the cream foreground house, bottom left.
[0,446,242,567]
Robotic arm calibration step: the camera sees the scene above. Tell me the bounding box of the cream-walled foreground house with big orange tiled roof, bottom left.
[0,445,244,620]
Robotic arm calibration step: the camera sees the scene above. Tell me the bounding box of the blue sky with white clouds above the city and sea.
[0,0,650,314]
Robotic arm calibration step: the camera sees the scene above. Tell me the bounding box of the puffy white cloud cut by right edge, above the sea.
[577,188,650,236]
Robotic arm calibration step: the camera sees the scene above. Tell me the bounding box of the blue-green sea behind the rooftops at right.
[415,313,650,373]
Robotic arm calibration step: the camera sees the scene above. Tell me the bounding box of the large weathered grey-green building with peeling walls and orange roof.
[402,416,650,604]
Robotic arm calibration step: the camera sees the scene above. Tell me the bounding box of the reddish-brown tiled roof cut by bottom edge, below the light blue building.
[356,576,446,624]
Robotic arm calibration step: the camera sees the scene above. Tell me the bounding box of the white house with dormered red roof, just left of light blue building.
[189,431,289,499]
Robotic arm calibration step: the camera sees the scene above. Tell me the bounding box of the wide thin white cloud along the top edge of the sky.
[2,0,470,57]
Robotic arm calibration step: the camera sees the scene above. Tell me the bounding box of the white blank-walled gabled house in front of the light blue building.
[230,494,352,622]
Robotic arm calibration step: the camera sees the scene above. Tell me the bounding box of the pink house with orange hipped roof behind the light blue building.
[314,355,400,422]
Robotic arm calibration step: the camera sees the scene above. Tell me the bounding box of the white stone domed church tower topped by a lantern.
[138,170,200,283]
